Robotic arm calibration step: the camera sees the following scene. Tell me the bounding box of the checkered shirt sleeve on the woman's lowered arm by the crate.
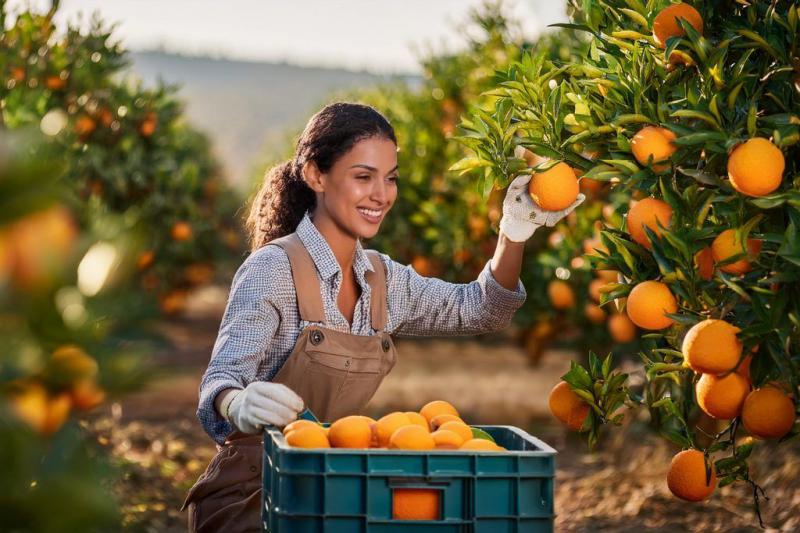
[197,246,289,443]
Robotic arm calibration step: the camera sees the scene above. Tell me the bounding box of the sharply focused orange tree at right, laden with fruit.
[456,0,800,516]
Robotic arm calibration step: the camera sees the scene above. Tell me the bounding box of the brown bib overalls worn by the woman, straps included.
[182,233,397,533]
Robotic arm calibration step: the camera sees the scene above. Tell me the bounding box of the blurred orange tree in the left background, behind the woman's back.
[0,2,244,313]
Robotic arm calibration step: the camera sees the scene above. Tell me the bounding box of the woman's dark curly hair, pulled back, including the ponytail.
[246,102,397,251]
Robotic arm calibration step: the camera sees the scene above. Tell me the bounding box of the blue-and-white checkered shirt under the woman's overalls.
[197,213,525,443]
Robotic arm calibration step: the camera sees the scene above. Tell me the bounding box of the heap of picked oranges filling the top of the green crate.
[283,400,505,451]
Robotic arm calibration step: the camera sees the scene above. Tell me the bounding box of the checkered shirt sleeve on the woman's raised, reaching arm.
[381,254,526,335]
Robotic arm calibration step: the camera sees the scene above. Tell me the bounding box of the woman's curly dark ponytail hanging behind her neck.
[245,159,317,251]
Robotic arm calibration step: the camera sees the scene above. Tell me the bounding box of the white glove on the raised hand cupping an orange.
[500,169,586,242]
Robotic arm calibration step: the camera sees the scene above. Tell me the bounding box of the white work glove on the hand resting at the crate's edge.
[220,381,305,434]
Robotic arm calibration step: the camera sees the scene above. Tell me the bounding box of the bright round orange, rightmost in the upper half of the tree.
[728,137,786,196]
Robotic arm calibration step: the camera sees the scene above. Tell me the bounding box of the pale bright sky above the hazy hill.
[7,0,566,73]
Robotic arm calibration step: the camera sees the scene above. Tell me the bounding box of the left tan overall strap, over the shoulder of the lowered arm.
[267,233,326,323]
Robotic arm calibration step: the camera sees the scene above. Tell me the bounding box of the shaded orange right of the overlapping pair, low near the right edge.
[742,385,795,439]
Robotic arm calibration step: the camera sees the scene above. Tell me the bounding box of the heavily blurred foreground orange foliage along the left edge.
[0,133,155,531]
